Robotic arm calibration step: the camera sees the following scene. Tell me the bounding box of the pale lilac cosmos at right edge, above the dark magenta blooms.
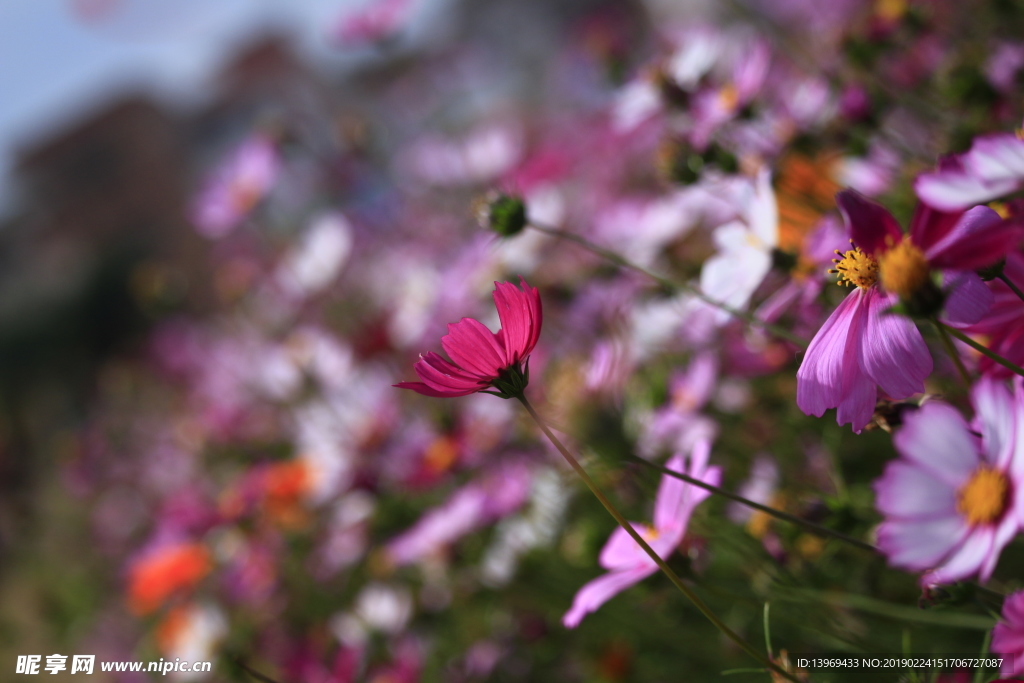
[914,133,1024,211]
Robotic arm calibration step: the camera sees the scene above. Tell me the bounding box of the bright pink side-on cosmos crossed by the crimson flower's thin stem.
[562,440,722,629]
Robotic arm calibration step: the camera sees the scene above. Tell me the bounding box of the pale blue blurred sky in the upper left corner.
[0,0,436,214]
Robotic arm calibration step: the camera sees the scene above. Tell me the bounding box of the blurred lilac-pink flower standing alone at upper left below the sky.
[191,134,281,239]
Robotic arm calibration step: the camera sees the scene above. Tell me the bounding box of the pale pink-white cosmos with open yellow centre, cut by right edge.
[874,379,1024,585]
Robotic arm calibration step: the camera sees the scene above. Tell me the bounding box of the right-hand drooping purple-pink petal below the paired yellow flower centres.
[860,290,932,398]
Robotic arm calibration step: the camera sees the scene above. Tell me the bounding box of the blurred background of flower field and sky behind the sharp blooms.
[0,0,1024,683]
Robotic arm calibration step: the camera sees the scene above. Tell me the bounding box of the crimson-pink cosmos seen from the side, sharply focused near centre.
[394,278,542,398]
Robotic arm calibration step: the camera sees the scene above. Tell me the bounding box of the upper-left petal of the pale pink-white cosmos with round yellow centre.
[893,401,980,488]
